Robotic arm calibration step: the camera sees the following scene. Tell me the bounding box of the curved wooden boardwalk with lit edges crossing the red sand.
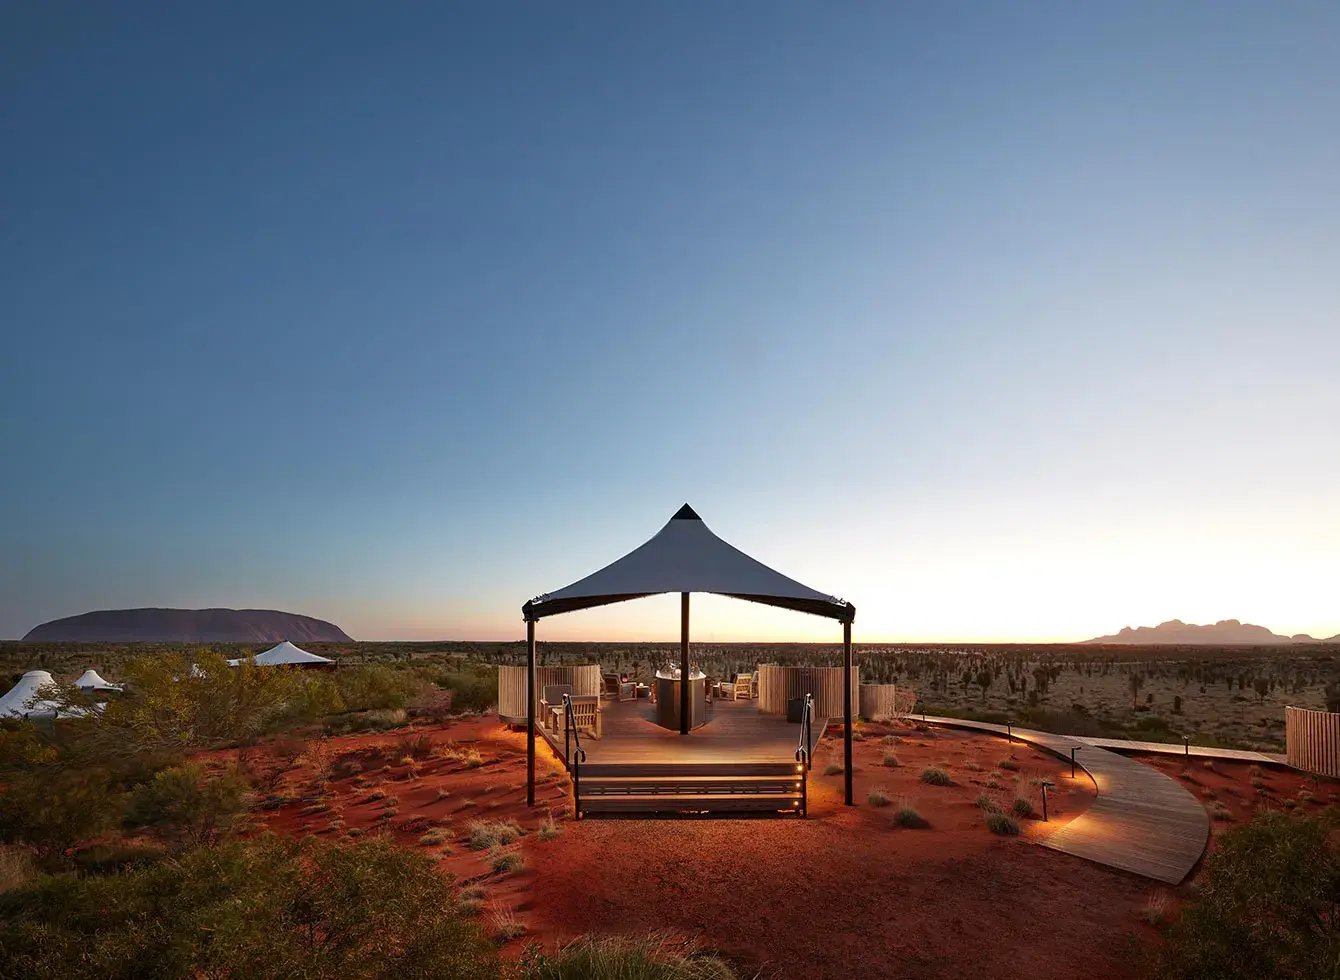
[926,717,1210,885]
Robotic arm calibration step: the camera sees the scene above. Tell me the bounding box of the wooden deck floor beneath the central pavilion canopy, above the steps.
[544,700,827,765]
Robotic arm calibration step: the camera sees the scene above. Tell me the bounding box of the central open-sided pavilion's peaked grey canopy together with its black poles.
[521,504,856,806]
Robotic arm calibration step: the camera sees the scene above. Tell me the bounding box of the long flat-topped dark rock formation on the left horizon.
[24,609,350,644]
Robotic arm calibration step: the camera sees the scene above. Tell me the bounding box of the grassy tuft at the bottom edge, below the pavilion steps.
[523,936,737,980]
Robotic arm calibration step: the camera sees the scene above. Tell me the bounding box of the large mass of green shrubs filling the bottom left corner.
[0,837,498,980]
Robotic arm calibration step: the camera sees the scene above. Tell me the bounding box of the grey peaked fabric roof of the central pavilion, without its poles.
[521,504,856,622]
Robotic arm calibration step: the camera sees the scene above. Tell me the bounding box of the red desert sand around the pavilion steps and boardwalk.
[198,717,1336,980]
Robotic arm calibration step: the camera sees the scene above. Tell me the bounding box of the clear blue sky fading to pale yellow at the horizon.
[0,1,1340,641]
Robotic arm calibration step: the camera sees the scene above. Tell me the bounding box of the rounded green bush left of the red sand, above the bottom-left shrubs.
[126,763,251,843]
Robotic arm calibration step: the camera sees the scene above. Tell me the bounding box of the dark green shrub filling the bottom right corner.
[1154,811,1340,980]
